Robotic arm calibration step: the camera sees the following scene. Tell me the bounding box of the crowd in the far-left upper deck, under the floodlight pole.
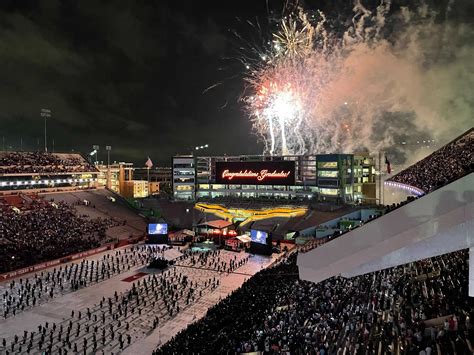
[0,152,96,174]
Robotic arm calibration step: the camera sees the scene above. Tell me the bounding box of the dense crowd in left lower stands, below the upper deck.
[0,199,118,273]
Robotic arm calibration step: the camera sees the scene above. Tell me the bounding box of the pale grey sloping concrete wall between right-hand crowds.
[298,173,474,290]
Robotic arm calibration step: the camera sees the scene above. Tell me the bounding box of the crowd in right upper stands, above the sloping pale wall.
[388,129,474,193]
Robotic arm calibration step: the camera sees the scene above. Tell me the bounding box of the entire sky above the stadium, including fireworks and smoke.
[0,0,474,164]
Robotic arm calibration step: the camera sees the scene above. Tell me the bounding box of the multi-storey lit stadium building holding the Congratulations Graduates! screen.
[173,154,375,202]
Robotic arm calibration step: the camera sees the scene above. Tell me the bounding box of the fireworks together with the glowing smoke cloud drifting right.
[241,1,474,162]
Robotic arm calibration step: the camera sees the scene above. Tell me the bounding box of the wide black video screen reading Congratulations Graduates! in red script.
[216,161,295,185]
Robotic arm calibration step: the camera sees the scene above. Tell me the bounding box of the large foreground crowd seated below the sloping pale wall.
[155,250,474,355]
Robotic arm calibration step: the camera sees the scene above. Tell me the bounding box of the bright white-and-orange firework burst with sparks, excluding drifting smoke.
[243,9,338,155]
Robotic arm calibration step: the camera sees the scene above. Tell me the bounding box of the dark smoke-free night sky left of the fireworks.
[0,0,470,165]
